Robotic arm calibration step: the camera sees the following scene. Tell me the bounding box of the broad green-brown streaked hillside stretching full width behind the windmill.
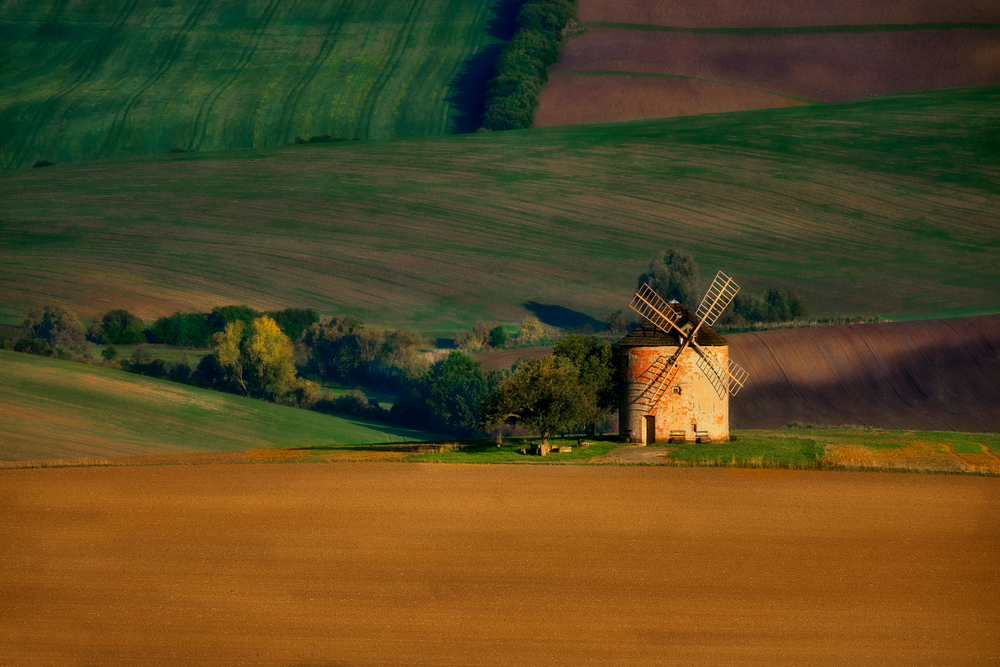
[0,87,1000,332]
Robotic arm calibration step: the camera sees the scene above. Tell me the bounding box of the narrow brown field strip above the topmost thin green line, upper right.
[577,0,1000,28]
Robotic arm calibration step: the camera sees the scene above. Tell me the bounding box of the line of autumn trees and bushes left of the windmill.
[2,304,617,439]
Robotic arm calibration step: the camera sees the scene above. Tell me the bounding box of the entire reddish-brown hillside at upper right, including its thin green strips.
[535,0,1000,127]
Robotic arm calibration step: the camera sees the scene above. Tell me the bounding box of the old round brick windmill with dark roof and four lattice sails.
[616,271,747,445]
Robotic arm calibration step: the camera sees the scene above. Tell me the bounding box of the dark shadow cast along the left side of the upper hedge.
[448,0,521,134]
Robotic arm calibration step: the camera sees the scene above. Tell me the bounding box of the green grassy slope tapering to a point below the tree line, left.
[0,350,442,461]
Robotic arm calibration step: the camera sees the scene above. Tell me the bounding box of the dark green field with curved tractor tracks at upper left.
[0,0,510,171]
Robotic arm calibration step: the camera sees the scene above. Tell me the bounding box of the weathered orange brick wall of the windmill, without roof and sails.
[618,346,729,444]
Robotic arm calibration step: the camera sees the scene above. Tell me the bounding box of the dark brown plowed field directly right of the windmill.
[727,315,1000,432]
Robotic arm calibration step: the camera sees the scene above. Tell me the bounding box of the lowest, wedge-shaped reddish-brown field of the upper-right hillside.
[535,75,803,127]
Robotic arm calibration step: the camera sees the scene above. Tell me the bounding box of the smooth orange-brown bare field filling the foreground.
[0,463,1000,665]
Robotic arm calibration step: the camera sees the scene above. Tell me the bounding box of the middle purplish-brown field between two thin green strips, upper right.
[552,28,1000,103]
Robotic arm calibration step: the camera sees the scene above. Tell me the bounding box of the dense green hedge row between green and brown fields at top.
[483,0,576,130]
